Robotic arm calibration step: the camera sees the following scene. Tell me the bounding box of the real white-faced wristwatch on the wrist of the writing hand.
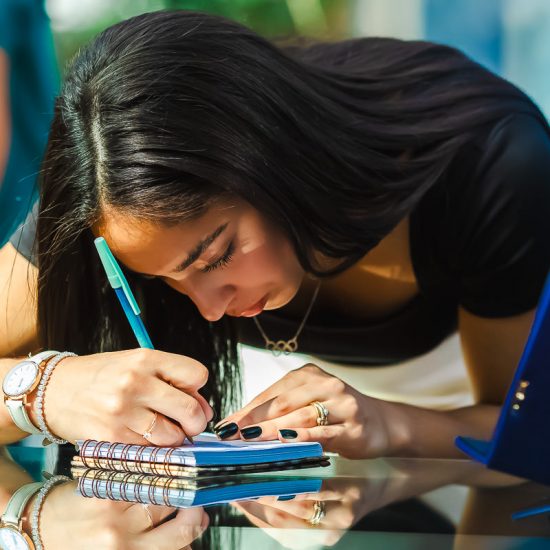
[2,351,59,434]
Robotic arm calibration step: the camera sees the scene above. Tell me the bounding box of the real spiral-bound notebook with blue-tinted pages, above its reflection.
[77,434,327,476]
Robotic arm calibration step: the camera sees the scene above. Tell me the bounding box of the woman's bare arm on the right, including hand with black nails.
[218,310,534,458]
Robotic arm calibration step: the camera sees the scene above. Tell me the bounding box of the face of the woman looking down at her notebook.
[98,200,304,321]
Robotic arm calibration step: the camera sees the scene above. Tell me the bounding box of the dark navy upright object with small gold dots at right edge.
[456,277,550,484]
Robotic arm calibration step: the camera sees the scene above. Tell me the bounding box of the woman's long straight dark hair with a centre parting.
[38,11,545,414]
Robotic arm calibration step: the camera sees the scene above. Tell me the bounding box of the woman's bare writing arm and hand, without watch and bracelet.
[0,243,213,445]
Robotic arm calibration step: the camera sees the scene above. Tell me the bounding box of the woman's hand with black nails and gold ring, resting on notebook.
[215,364,407,458]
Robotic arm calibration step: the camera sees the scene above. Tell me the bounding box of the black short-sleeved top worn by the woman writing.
[11,114,550,365]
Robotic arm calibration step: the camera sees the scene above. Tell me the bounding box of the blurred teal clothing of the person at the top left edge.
[0,0,59,246]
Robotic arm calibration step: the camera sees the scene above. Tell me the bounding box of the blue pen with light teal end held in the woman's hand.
[94,237,155,349]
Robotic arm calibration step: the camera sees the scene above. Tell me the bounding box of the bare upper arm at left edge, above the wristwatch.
[0,242,38,357]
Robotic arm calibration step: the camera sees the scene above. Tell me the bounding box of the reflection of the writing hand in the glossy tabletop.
[40,482,208,550]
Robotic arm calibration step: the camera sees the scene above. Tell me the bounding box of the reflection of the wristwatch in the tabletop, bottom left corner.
[0,482,44,550]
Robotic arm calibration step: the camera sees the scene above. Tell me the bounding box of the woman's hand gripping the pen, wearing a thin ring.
[29,348,213,446]
